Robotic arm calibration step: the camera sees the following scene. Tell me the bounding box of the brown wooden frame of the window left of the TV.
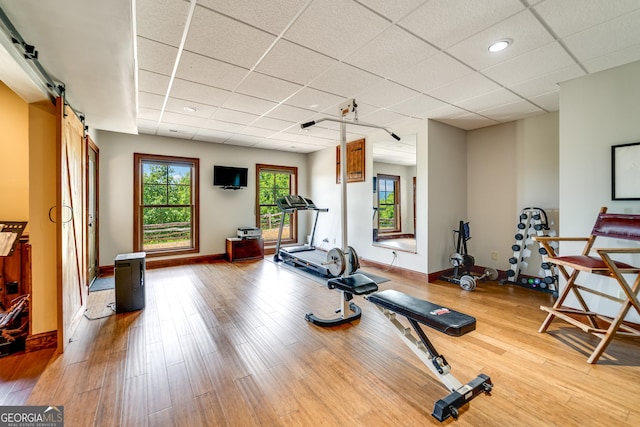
[133,153,200,257]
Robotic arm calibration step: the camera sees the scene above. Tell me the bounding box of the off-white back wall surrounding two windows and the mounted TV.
[95,131,308,266]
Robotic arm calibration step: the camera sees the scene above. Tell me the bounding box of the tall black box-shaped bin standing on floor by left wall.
[114,252,146,313]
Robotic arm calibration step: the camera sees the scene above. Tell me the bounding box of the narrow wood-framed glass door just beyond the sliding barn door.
[86,139,99,286]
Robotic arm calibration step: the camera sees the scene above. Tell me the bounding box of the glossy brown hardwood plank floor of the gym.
[0,261,640,426]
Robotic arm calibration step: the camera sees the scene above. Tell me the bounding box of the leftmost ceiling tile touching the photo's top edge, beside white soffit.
[135,0,190,47]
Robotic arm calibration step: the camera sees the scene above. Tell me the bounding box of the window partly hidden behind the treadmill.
[256,165,298,243]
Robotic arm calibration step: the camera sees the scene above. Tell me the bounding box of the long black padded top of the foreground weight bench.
[367,289,476,337]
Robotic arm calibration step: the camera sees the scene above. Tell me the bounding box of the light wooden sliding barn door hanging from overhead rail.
[56,98,87,351]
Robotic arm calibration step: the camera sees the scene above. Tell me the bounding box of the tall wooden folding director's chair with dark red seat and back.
[533,207,640,363]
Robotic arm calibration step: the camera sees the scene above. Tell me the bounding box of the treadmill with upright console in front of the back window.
[273,194,333,277]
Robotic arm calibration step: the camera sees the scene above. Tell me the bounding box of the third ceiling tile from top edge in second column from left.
[176,52,248,90]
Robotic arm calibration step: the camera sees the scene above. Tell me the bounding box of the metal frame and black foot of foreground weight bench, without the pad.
[376,305,493,421]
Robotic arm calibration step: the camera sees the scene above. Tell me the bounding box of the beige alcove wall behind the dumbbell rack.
[467,112,559,277]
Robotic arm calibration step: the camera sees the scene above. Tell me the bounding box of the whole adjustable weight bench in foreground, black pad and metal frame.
[366,289,493,421]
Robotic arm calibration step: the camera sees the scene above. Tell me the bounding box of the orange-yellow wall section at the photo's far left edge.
[0,81,29,222]
